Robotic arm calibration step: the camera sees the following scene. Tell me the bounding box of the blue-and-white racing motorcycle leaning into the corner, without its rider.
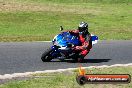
[41,26,98,62]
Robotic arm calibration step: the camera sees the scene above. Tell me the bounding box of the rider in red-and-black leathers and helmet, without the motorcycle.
[69,22,92,62]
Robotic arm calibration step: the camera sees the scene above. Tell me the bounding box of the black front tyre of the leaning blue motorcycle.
[41,48,53,62]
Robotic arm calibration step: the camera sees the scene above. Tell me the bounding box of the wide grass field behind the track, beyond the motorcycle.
[0,0,132,41]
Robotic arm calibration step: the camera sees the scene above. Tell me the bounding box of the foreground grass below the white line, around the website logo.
[0,66,132,88]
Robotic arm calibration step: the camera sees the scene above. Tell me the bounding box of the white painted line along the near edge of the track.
[0,63,132,79]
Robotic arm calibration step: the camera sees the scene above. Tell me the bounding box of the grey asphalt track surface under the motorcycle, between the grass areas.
[0,40,132,75]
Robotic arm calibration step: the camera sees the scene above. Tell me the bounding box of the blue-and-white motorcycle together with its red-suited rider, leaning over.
[41,22,98,62]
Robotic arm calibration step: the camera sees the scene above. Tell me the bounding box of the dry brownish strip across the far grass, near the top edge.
[0,2,102,14]
